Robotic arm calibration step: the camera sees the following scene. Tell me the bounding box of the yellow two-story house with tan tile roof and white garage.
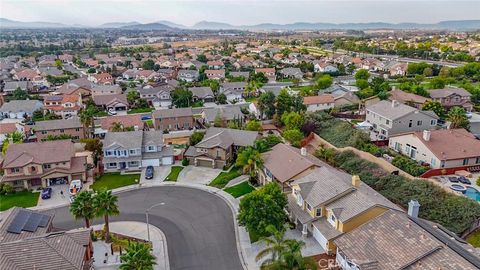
[287,165,400,254]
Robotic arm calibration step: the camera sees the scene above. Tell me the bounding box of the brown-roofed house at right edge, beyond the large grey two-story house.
[428,88,473,112]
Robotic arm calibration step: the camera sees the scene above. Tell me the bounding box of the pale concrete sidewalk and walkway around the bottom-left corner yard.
[93,221,170,270]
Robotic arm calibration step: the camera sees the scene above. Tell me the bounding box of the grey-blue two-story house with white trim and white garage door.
[102,130,173,171]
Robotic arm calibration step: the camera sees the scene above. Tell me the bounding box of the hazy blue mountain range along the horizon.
[0,18,480,31]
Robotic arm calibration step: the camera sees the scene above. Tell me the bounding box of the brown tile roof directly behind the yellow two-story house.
[262,143,323,183]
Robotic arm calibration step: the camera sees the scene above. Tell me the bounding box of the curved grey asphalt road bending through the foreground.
[41,186,243,270]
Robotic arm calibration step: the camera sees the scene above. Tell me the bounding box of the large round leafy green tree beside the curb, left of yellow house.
[237,183,287,237]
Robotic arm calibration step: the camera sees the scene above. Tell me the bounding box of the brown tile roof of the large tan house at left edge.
[3,140,75,168]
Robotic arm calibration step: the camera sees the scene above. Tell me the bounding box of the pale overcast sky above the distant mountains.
[0,0,480,26]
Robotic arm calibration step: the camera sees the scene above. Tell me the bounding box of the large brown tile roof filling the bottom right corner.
[334,210,477,269]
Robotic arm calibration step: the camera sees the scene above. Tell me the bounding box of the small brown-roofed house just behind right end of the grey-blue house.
[152,108,195,131]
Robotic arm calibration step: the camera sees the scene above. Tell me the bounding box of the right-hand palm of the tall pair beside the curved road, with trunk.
[94,190,120,243]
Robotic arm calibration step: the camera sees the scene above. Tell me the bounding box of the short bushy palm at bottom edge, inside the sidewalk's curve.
[120,242,157,270]
